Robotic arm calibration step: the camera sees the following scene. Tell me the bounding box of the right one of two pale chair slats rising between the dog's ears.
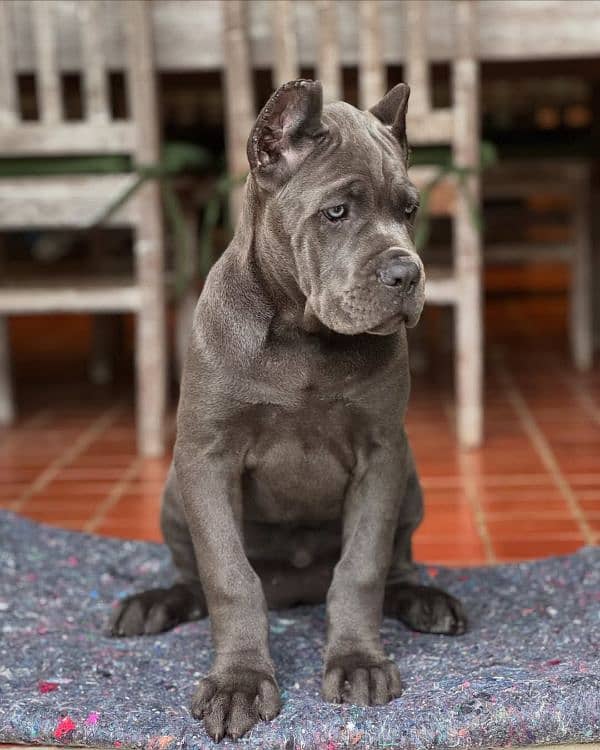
[358,0,386,109]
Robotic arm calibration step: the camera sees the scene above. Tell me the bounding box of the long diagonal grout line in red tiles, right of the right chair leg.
[494,356,594,544]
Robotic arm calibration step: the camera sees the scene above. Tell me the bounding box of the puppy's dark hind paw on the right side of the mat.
[384,583,467,635]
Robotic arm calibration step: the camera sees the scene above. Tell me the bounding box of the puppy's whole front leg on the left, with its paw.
[175,446,280,741]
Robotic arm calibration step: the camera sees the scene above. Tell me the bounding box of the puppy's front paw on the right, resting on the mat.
[322,652,402,706]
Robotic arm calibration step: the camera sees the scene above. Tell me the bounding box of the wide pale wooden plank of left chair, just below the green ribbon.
[0,174,137,230]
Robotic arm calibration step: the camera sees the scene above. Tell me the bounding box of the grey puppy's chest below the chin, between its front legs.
[244,339,404,521]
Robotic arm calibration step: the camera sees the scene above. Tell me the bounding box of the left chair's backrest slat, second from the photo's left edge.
[30,0,62,125]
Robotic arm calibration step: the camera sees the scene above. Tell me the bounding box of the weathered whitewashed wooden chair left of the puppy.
[0,0,166,456]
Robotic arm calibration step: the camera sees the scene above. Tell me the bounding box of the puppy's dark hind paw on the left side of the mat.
[110,584,207,636]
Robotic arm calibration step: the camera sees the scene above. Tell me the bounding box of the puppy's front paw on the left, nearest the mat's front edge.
[192,667,281,742]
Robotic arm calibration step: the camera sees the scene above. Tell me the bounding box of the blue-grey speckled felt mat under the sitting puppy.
[0,512,600,750]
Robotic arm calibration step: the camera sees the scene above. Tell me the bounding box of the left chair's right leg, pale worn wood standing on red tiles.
[135,184,167,457]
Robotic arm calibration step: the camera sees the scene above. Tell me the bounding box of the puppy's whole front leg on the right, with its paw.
[323,444,406,705]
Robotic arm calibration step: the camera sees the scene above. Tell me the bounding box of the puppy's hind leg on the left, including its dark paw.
[110,467,208,636]
